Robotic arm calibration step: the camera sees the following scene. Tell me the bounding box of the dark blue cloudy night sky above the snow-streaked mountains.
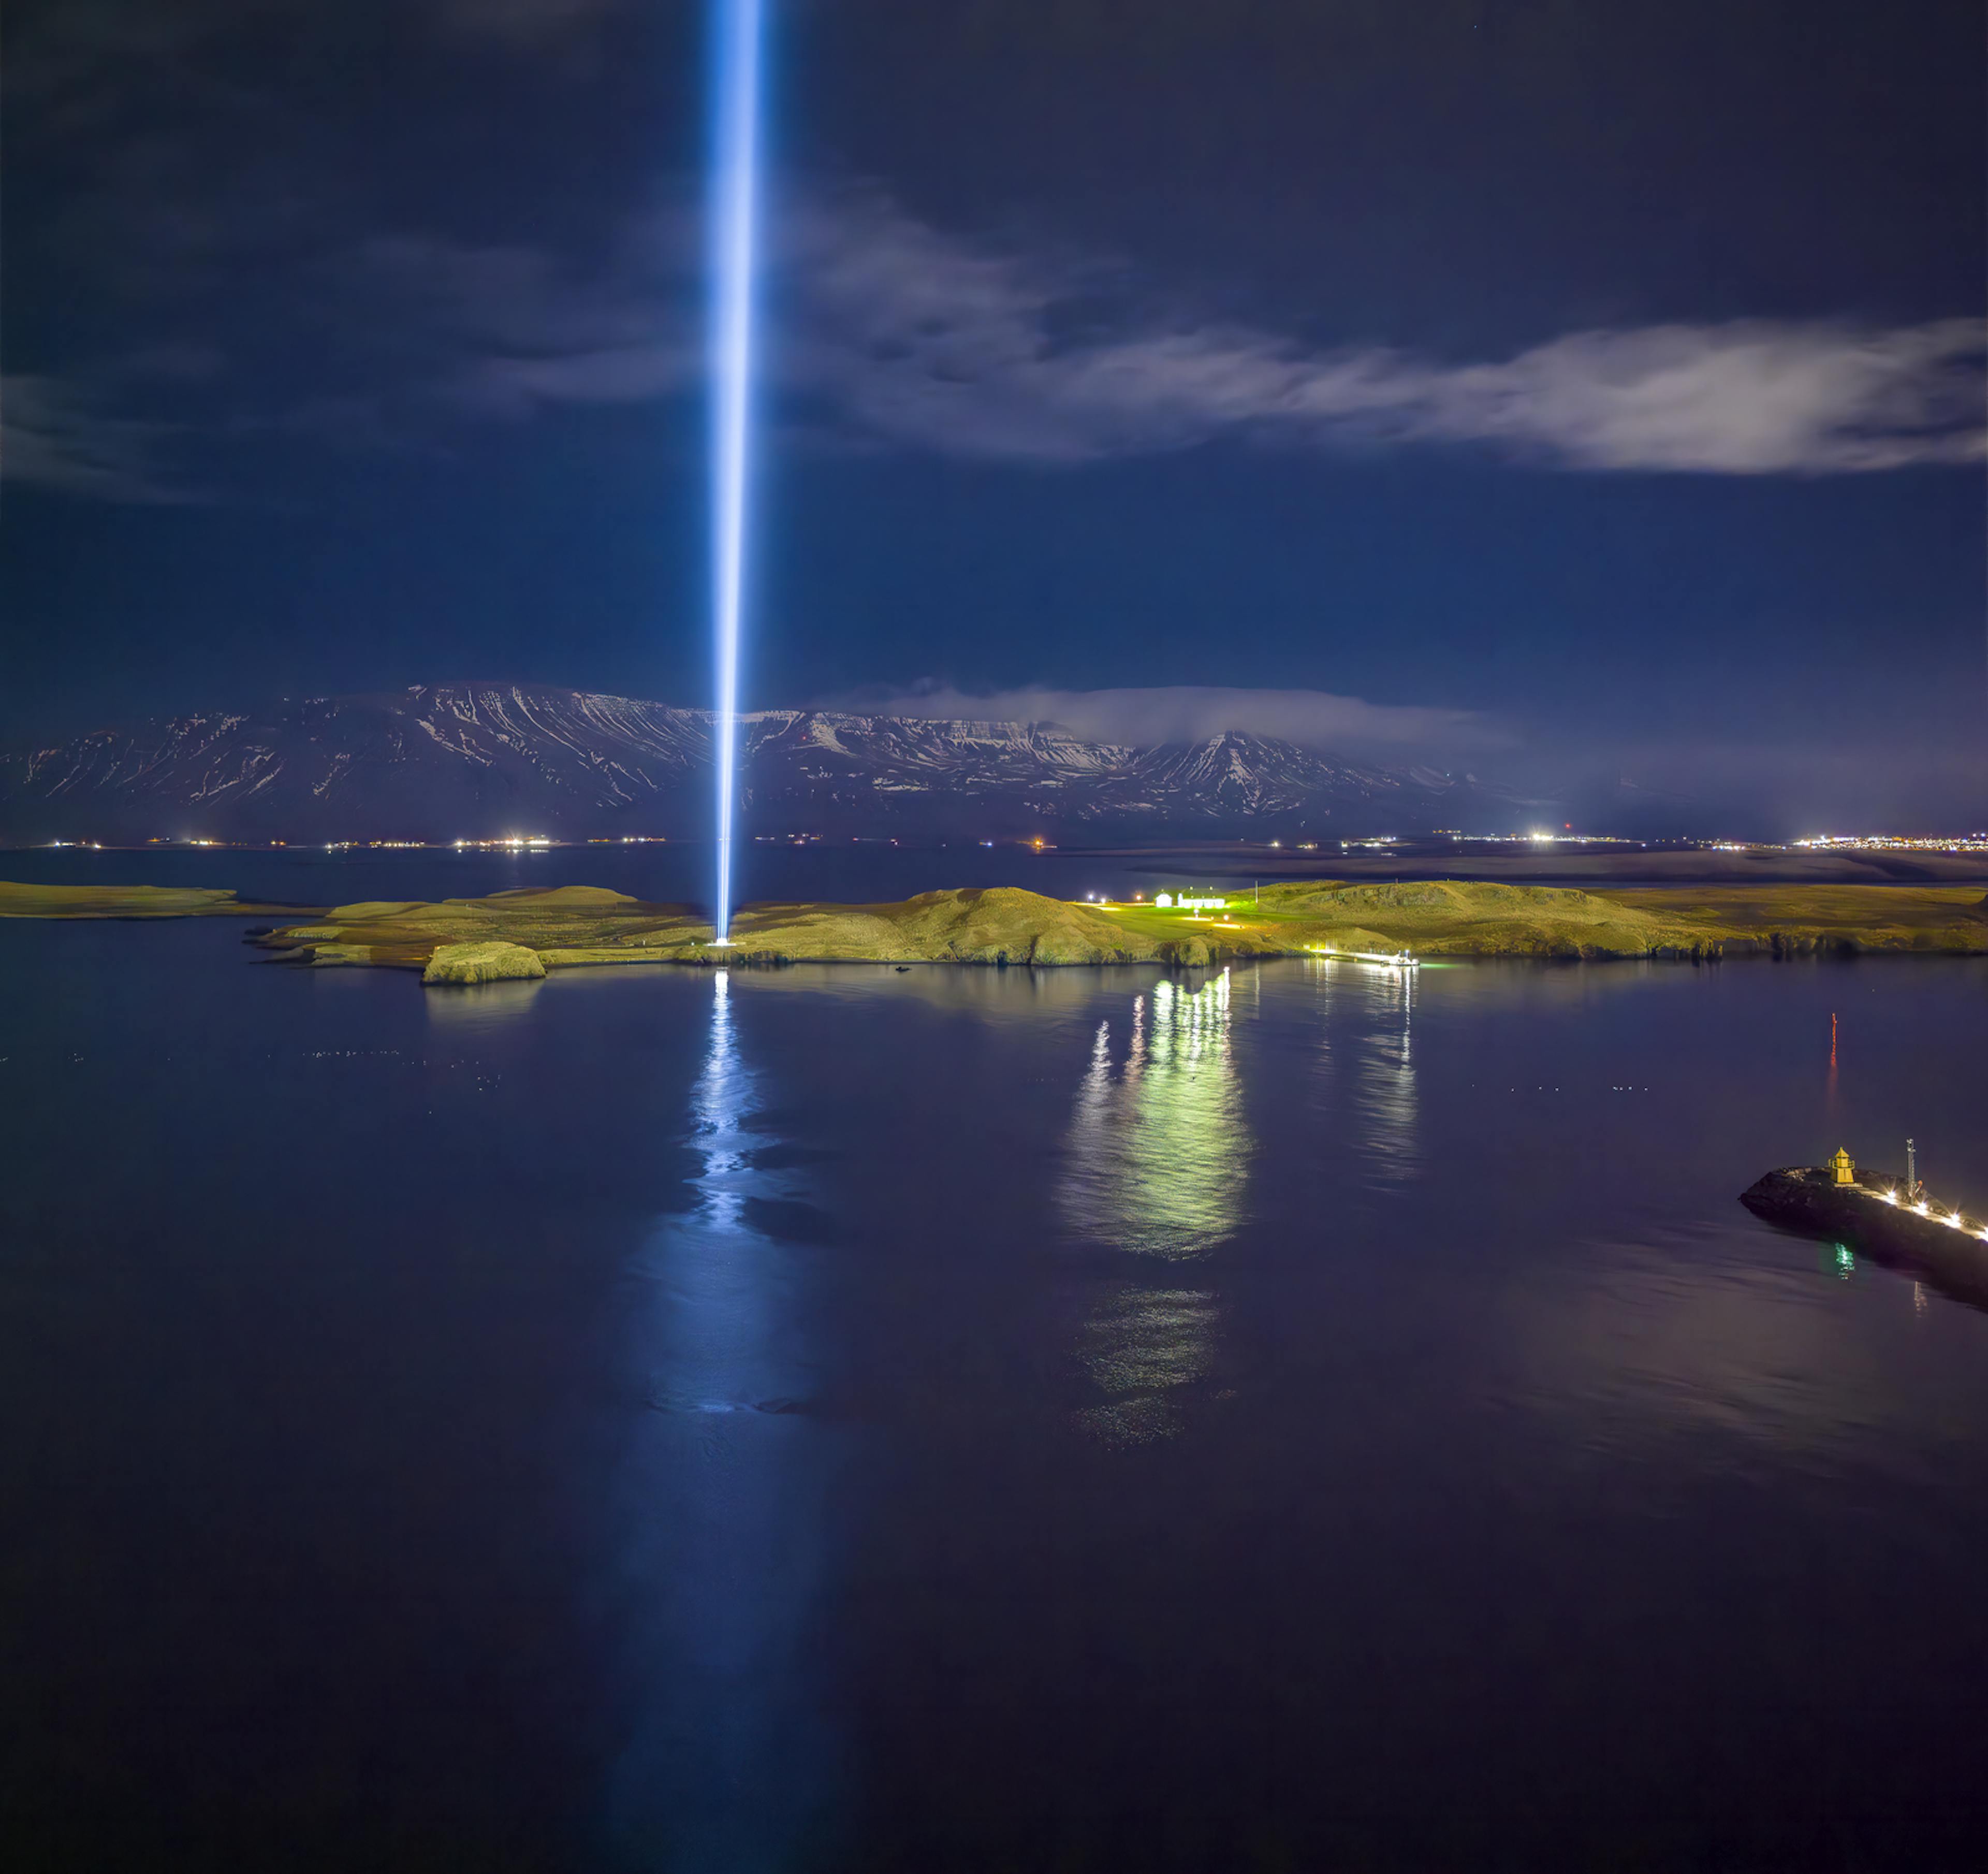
[0,0,1988,832]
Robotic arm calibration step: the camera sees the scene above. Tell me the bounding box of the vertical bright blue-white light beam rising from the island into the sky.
[710,0,765,943]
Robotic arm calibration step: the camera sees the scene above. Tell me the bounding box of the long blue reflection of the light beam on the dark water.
[610,971,829,1874]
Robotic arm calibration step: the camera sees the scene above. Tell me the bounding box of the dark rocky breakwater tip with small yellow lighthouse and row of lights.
[1740,1148,1988,1307]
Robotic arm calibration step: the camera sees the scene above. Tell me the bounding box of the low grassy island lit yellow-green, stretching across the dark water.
[0,879,1988,985]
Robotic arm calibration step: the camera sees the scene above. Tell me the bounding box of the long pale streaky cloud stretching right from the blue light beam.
[789,195,1988,475]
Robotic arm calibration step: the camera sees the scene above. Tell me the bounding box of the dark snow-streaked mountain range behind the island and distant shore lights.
[0,682,1509,841]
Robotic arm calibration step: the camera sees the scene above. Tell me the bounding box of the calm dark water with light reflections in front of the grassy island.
[0,903,1988,1874]
